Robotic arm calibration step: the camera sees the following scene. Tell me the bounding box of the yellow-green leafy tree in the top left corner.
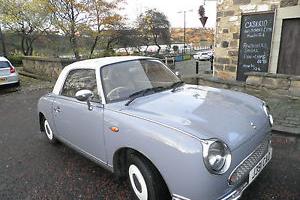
[0,0,50,55]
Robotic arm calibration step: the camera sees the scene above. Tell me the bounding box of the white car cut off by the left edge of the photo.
[0,57,20,86]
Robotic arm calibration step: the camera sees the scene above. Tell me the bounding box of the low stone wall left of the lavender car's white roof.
[22,56,74,81]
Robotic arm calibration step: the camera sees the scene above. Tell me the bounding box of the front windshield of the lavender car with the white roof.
[101,60,180,103]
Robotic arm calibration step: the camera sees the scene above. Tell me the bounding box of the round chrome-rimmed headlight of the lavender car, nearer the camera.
[203,139,231,174]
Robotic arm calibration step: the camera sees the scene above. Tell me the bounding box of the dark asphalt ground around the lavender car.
[0,89,300,200]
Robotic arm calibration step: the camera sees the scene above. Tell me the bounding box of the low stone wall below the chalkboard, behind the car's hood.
[184,72,300,134]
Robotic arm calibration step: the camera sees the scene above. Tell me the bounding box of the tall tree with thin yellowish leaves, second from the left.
[48,0,88,59]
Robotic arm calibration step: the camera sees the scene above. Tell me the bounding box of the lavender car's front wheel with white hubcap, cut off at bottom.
[128,154,171,200]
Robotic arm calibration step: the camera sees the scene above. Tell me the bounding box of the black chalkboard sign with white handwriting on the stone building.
[237,13,274,81]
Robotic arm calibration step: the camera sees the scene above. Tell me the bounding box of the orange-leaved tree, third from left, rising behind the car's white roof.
[88,0,123,58]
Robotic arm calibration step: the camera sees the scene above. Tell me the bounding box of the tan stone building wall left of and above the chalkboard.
[214,0,300,80]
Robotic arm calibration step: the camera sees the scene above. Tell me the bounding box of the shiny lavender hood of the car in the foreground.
[115,85,269,149]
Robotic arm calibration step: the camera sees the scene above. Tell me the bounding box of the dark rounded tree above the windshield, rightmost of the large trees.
[137,9,170,54]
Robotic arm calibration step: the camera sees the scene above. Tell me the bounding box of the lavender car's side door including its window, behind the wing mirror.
[53,69,106,163]
